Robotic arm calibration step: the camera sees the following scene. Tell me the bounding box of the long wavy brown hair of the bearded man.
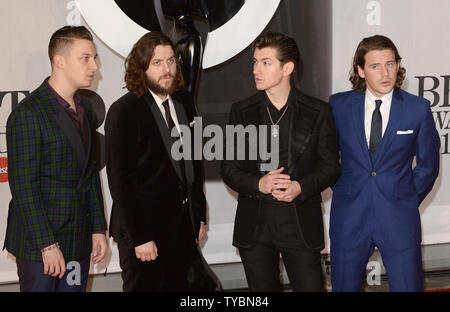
[125,31,184,97]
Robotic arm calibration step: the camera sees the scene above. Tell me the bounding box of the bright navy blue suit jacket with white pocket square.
[330,89,440,248]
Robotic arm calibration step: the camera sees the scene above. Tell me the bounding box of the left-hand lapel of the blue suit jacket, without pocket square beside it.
[351,92,372,163]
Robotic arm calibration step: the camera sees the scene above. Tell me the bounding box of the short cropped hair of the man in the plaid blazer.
[48,26,94,63]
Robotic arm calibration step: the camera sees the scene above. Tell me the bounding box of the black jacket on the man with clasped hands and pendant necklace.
[221,88,340,249]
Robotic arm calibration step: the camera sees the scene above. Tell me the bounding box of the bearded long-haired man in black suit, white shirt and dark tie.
[105,31,206,291]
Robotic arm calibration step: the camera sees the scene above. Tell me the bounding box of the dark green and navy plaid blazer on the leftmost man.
[3,81,106,262]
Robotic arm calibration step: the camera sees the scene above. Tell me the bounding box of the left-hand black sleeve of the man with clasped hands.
[221,105,261,195]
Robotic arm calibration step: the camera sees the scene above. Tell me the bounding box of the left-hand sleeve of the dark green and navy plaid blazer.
[6,104,55,249]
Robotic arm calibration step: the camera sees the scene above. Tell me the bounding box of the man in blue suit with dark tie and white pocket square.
[330,35,440,291]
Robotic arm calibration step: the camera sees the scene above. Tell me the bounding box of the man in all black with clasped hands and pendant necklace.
[221,32,340,291]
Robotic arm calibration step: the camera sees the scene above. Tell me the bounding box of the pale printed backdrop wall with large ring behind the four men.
[0,0,450,283]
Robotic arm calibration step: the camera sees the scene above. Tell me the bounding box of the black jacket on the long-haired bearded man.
[105,92,206,254]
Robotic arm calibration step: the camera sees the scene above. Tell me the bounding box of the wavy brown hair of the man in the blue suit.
[349,35,406,92]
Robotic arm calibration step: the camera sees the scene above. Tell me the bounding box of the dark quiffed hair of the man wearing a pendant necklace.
[253,31,301,73]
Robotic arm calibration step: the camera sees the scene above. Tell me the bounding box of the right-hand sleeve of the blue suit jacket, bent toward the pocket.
[413,101,441,202]
